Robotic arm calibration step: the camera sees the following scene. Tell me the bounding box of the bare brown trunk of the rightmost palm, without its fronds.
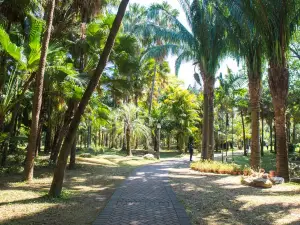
[269,63,289,181]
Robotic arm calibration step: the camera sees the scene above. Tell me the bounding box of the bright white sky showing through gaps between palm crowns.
[130,0,239,87]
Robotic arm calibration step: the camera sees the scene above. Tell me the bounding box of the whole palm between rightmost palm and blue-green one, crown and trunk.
[219,1,263,169]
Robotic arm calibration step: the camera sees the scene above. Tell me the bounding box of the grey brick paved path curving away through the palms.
[93,161,190,225]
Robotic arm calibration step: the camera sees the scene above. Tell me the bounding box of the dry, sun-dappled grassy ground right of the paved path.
[170,163,300,225]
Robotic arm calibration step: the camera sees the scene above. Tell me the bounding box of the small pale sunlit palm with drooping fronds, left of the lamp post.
[119,103,150,156]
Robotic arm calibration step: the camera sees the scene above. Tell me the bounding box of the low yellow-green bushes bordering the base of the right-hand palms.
[191,160,252,176]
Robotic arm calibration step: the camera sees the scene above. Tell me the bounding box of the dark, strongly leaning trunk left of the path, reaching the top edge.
[49,0,129,197]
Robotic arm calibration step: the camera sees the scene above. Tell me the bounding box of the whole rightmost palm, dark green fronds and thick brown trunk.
[227,0,300,180]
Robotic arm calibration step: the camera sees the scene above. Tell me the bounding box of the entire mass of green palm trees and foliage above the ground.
[0,0,300,196]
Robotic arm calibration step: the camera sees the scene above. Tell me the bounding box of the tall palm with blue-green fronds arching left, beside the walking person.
[145,0,226,159]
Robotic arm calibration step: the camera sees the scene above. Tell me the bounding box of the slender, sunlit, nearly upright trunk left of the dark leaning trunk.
[24,0,55,181]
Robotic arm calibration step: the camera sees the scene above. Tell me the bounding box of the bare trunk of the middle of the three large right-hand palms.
[248,78,261,170]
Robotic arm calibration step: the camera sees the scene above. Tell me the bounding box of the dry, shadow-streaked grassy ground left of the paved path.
[0,151,155,225]
